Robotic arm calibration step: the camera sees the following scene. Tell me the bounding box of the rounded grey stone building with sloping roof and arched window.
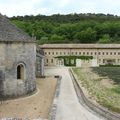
[0,15,36,97]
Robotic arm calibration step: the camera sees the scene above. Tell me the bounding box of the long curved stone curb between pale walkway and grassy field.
[69,69,120,120]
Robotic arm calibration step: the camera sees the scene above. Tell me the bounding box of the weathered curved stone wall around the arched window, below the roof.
[0,42,36,96]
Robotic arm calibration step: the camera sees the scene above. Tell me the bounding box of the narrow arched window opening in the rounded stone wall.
[17,64,25,80]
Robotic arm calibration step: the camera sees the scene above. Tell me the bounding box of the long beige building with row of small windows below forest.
[40,44,120,67]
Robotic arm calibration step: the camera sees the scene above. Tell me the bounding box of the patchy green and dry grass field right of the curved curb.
[73,67,120,113]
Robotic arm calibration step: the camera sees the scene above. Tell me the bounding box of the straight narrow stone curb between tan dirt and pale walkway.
[48,76,62,120]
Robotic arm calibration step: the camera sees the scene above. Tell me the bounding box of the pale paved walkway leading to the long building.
[45,67,103,120]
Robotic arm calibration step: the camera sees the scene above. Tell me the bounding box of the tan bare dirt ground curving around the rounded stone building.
[0,77,56,119]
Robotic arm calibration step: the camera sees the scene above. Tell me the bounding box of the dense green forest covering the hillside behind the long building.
[9,13,120,44]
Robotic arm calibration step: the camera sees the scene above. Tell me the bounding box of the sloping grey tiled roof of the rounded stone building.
[0,14,34,42]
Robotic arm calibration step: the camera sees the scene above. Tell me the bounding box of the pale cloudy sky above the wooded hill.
[0,0,120,17]
